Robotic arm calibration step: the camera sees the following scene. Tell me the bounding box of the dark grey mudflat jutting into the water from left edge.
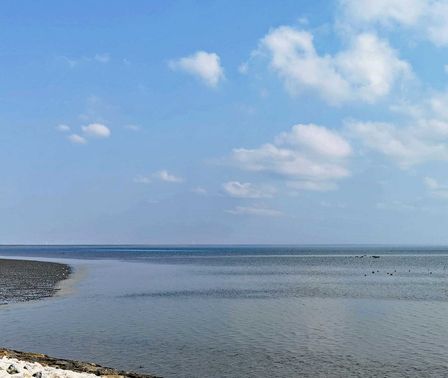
[0,259,72,304]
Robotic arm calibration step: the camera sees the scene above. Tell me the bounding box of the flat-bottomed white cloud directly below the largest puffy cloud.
[231,124,352,189]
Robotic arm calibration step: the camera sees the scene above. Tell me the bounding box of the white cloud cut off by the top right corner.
[340,0,448,46]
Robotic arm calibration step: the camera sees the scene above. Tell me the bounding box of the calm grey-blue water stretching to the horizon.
[0,246,448,377]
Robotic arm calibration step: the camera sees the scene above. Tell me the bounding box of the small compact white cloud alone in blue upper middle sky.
[169,51,224,87]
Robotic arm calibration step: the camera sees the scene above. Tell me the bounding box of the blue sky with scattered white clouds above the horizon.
[4,0,448,244]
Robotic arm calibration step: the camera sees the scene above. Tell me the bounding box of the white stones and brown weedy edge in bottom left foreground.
[0,349,155,378]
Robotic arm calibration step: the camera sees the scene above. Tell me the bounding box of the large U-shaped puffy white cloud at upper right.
[258,26,411,104]
